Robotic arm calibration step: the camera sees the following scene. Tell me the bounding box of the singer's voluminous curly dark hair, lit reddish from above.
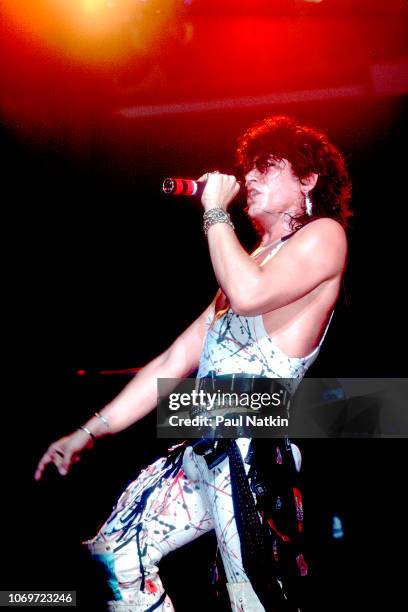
[237,116,353,230]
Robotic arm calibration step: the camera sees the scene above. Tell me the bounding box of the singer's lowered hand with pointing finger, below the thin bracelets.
[34,429,93,480]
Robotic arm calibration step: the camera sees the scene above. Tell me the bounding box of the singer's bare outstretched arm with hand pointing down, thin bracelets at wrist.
[34,305,212,480]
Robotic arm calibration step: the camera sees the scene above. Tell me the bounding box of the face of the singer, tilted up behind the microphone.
[245,159,303,218]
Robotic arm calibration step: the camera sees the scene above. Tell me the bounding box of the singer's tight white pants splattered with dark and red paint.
[85,439,264,612]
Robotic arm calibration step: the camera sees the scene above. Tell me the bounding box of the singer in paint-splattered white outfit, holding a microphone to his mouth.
[35,116,351,612]
